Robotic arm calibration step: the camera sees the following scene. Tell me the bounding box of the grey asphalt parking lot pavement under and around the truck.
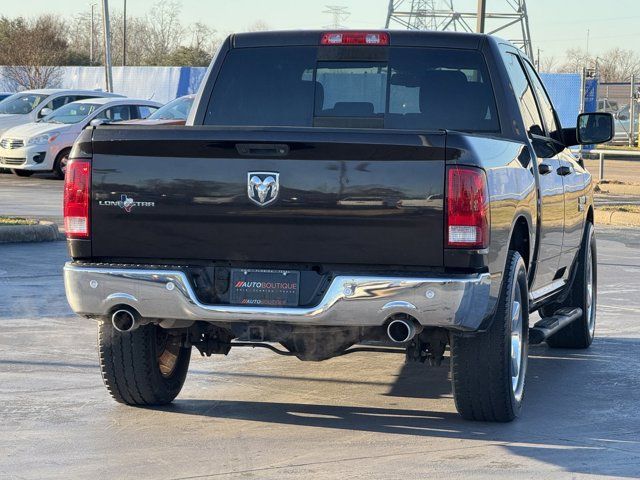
[0,229,640,480]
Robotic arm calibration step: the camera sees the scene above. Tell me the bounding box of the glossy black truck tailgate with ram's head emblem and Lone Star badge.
[91,126,445,267]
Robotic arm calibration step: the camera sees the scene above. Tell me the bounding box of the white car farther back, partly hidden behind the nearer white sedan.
[0,88,123,136]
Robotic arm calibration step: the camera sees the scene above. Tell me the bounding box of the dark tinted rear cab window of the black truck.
[204,46,500,132]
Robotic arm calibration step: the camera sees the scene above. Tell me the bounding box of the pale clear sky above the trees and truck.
[8,0,640,58]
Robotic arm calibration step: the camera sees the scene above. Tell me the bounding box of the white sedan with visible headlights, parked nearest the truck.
[0,98,162,178]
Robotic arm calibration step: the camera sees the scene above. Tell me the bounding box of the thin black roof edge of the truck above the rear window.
[231,29,496,49]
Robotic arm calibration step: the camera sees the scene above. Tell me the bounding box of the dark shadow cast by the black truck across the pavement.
[159,338,640,478]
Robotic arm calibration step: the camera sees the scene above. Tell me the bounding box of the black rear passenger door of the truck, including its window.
[504,51,564,290]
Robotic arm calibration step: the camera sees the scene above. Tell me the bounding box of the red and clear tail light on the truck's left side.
[64,160,91,238]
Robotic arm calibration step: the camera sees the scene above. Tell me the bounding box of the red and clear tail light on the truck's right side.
[447,166,489,248]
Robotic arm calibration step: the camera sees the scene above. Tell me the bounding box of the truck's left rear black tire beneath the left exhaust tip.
[98,319,191,405]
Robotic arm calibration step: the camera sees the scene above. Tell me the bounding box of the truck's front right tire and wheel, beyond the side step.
[544,223,598,348]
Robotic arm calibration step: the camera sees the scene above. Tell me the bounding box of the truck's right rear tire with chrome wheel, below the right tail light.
[451,250,529,422]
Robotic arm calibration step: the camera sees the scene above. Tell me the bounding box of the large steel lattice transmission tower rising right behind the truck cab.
[386,0,533,58]
